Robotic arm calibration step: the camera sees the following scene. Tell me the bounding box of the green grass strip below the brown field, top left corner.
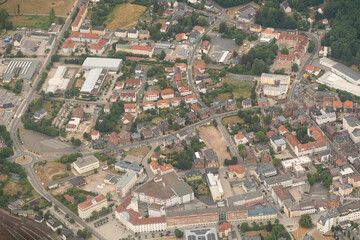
[10,16,64,29]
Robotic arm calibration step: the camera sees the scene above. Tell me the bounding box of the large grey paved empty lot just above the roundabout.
[20,130,78,155]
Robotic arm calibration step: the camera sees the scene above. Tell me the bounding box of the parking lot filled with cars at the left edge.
[0,89,21,126]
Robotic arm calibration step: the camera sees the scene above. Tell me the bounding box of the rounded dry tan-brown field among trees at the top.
[106,3,146,30]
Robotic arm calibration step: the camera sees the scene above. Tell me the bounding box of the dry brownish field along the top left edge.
[1,0,75,16]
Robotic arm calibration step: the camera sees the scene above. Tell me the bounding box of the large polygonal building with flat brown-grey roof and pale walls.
[132,171,194,208]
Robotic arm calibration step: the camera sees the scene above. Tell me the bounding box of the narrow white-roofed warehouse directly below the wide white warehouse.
[80,68,107,96]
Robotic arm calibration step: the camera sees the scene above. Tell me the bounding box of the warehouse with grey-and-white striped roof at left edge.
[2,60,40,83]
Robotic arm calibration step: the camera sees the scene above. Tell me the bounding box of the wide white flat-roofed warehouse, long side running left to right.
[82,57,122,72]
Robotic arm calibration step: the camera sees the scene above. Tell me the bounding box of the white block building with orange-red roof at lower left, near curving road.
[78,194,108,219]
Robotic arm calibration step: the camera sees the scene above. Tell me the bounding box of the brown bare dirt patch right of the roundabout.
[34,162,71,186]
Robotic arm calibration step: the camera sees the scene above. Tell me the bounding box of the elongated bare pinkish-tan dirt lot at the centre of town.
[198,126,231,164]
